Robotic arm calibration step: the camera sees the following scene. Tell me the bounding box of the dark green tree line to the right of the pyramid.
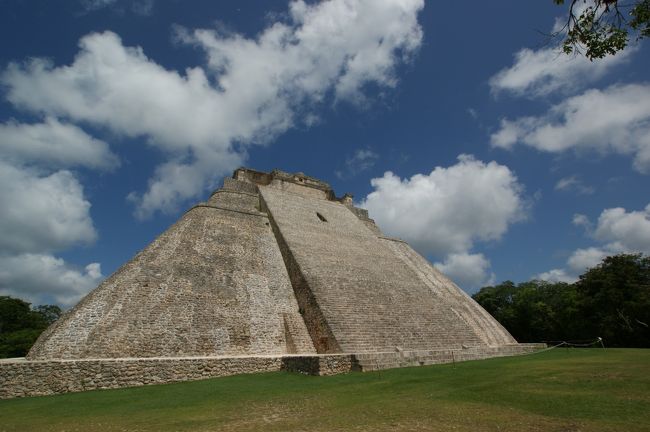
[472,254,650,348]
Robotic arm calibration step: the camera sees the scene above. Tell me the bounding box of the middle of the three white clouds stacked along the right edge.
[491,84,650,173]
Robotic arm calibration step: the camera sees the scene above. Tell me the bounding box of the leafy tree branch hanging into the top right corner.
[553,0,650,60]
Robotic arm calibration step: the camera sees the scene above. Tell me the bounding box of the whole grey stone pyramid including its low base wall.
[0,168,543,399]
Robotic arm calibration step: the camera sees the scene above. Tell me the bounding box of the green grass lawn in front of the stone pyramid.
[0,348,650,432]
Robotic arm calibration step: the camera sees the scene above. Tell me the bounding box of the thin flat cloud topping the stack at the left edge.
[0,117,119,170]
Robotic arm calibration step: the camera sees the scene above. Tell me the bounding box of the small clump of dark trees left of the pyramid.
[0,296,61,358]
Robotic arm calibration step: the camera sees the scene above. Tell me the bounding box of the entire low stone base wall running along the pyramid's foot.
[0,344,545,399]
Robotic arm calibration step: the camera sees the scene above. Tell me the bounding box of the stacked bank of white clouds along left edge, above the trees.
[0,118,105,306]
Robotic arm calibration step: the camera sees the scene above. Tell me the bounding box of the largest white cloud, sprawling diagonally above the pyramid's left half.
[1,0,424,217]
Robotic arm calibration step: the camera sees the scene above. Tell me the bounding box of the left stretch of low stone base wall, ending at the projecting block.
[0,355,352,399]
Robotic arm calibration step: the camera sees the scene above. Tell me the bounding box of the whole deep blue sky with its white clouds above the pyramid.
[0,0,650,306]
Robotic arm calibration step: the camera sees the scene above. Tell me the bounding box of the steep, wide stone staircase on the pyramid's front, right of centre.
[259,183,487,352]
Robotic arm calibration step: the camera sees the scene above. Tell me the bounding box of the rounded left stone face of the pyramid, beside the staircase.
[29,186,315,359]
